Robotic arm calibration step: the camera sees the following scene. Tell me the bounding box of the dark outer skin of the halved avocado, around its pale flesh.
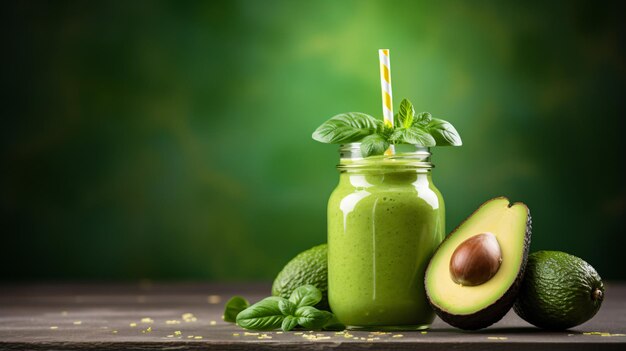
[424,196,532,330]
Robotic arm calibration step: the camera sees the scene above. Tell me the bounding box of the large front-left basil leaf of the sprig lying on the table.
[237,296,285,330]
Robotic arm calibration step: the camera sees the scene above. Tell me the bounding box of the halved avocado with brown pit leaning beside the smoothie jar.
[424,197,531,330]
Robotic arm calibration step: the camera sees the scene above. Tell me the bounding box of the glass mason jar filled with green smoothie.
[328,143,445,329]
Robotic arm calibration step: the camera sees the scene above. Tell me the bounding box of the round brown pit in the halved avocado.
[450,232,502,286]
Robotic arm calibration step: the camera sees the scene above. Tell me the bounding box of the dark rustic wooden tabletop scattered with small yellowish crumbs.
[0,282,626,351]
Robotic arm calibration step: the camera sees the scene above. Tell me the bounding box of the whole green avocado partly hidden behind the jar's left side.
[272,244,330,311]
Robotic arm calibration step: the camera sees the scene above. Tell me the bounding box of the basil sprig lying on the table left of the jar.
[224,285,344,331]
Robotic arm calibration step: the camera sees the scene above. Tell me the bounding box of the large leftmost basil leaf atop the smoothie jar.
[313,112,382,144]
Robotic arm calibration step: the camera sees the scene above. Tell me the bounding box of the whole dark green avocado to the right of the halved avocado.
[513,251,604,330]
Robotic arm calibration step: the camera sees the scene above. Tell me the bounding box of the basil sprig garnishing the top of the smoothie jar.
[313,99,463,157]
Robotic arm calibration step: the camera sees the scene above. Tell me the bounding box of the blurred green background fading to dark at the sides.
[0,0,626,281]
